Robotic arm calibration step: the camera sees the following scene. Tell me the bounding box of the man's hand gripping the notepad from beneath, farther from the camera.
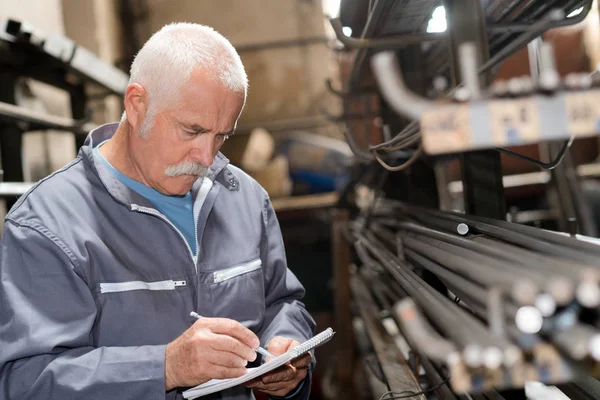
[246,336,312,397]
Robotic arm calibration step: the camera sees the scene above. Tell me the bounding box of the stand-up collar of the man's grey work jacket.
[79,122,239,207]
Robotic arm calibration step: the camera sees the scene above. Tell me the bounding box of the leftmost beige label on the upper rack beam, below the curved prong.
[421,104,471,154]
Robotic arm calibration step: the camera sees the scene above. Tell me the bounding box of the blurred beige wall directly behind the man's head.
[142,0,340,136]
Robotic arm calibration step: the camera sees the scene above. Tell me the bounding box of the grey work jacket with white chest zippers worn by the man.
[0,124,315,400]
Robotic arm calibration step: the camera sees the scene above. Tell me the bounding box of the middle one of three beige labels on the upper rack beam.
[489,99,541,146]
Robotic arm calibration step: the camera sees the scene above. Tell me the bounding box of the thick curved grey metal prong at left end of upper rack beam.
[371,51,436,119]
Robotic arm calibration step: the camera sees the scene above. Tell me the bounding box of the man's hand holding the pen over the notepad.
[165,318,259,391]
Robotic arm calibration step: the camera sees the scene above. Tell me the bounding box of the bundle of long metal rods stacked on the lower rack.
[352,199,600,391]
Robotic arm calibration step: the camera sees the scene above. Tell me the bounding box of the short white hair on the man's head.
[122,23,248,136]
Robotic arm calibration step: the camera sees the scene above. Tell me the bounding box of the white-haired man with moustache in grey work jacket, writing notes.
[0,24,314,400]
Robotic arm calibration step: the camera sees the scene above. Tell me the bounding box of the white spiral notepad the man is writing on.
[183,328,335,399]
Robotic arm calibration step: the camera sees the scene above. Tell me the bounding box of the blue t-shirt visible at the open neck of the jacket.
[94,144,196,255]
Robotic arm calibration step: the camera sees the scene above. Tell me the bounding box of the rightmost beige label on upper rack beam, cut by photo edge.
[565,90,600,136]
